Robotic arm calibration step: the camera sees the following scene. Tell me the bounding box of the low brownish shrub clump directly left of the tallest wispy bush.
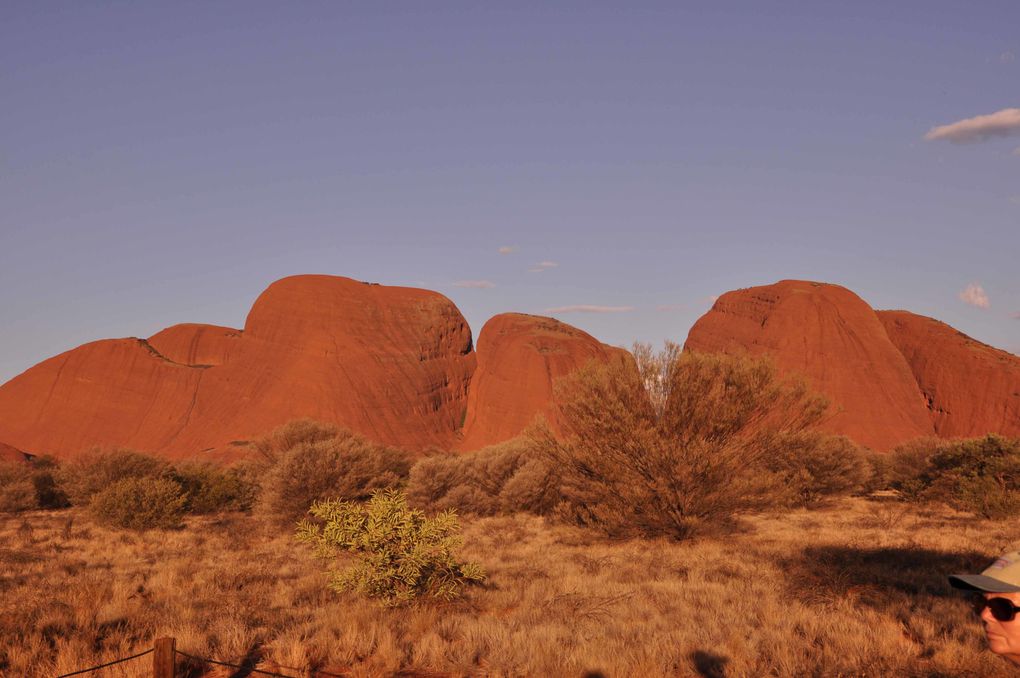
[407,433,559,516]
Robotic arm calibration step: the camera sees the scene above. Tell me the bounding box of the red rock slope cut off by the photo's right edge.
[878,311,1020,437]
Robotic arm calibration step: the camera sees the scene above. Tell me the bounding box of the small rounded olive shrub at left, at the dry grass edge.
[89,477,188,530]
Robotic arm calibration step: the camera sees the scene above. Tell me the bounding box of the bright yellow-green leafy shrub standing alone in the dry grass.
[297,489,485,606]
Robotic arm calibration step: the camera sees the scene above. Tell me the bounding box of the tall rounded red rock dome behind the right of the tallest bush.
[684,280,934,451]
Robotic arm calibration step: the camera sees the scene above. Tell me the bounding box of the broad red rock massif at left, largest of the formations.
[0,275,474,457]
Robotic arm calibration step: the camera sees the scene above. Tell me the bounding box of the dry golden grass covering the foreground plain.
[0,500,1020,678]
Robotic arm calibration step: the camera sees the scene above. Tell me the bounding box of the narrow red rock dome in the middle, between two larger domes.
[458,313,628,451]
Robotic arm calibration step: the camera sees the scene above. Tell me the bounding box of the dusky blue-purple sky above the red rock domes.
[0,1,1020,382]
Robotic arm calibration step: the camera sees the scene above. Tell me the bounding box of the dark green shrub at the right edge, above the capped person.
[901,435,1020,519]
